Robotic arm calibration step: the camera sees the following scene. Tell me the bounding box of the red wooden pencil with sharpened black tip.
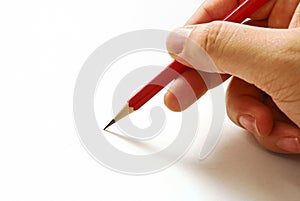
[104,0,268,130]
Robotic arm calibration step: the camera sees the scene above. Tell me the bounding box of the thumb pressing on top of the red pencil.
[167,21,295,89]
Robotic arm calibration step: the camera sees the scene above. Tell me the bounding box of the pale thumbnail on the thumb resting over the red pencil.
[167,27,193,54]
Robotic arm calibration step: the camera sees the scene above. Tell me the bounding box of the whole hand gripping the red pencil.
[165,0,300,154]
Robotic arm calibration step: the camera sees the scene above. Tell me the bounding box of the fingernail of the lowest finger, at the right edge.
[276,137,300,153]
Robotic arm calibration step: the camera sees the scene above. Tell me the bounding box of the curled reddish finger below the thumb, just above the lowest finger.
[226,78,273,138]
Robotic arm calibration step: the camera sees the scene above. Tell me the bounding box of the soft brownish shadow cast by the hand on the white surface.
[185,131,300,200]
